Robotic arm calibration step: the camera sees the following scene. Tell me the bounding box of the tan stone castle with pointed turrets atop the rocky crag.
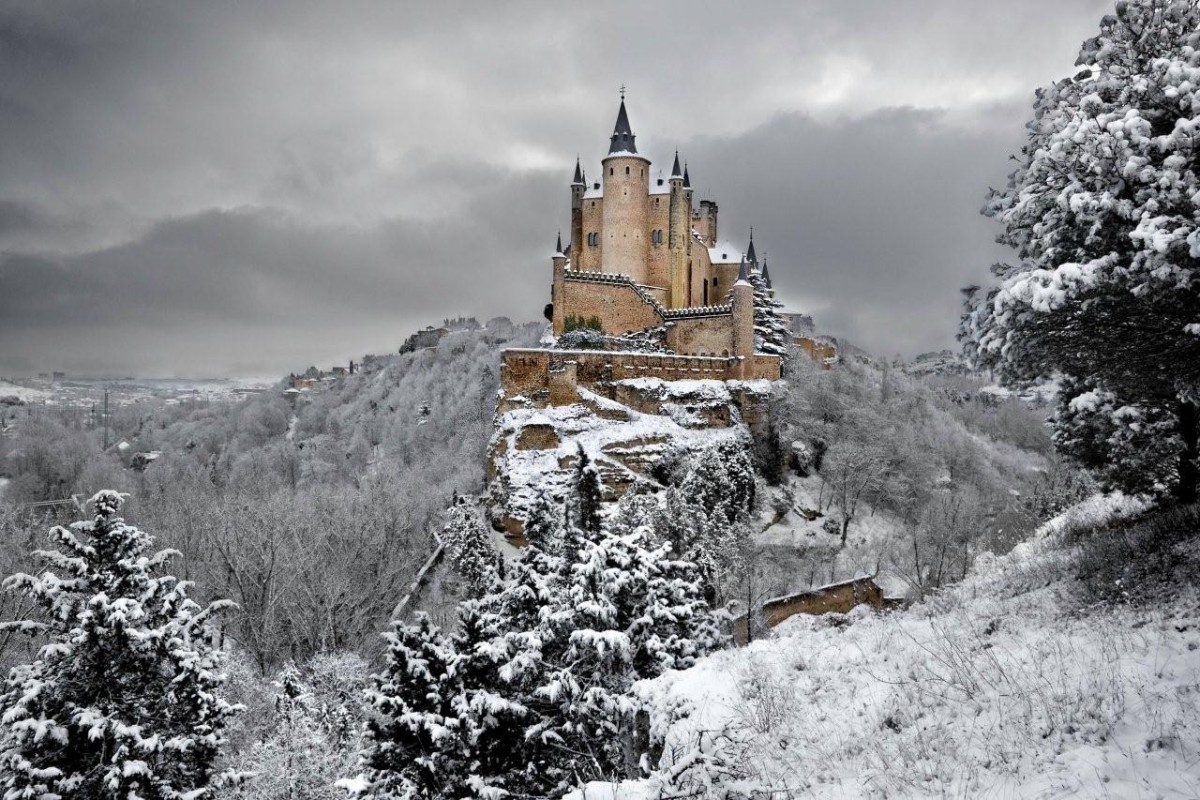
[547,97,780,380]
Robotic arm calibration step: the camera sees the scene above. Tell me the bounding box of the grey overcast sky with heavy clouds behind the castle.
[0,0,1111,377]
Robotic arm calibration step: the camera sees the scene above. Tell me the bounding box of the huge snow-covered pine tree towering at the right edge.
[960,0,1200,503]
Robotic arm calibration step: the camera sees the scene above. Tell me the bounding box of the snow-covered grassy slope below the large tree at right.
[571,497,1200,800]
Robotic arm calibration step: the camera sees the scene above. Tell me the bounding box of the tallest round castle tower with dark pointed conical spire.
[600,95,650,283]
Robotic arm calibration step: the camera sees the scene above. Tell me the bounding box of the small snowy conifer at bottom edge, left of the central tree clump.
[341,614,469,800]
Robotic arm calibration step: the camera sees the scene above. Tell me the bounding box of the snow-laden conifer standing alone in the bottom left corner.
[0,491,236,800]
